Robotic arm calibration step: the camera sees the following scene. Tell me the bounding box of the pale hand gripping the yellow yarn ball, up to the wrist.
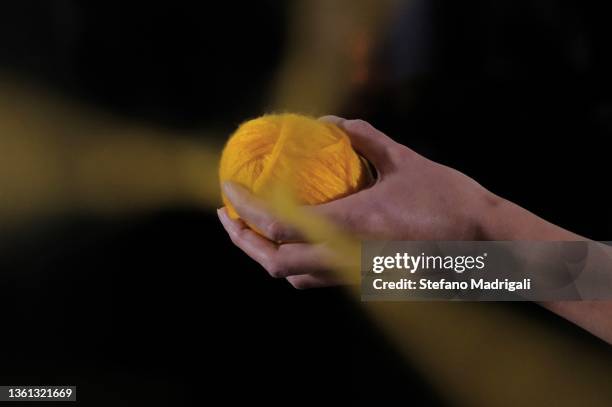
[218,116,501,288]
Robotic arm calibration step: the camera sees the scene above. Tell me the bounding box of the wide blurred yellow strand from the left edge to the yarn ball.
[0,78,220,226]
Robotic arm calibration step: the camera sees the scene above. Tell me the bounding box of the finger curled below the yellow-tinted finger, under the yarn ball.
[217,208,331,278]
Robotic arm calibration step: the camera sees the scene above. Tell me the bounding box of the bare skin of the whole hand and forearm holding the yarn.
[218,116,612,343]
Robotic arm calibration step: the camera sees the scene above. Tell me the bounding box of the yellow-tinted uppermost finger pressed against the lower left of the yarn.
[223,182,302,242]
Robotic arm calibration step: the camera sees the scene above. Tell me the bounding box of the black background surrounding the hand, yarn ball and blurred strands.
[0,0,612,405]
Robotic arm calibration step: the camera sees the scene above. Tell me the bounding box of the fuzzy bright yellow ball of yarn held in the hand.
[219,113,371,219]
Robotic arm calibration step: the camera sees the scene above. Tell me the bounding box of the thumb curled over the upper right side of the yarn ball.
[319,116,403,173]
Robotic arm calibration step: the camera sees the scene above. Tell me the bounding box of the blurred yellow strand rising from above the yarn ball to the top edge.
[271,0,394,116]
